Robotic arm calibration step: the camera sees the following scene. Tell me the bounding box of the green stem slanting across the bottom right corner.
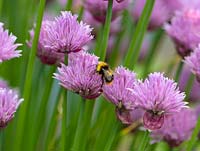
[186,117,200,151]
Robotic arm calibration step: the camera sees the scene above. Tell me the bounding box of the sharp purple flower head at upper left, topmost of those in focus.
[47,11,93,53]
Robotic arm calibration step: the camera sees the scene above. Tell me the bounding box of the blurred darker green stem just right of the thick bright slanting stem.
[143,29,164,77]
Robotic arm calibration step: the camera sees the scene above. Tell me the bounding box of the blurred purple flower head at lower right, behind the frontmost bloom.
[151,109,197,147]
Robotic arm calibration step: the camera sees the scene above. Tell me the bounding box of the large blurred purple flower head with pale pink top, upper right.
[165,9,200,57]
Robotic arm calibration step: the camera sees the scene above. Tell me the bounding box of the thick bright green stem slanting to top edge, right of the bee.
[124,0,155,69]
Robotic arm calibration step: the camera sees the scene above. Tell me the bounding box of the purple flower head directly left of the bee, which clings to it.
[54,52,102,99]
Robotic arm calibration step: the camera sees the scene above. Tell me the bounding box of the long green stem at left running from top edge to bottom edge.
[14,0,46,151]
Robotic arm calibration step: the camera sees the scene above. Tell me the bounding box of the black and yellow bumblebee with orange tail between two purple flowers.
[96,61,114,86]
